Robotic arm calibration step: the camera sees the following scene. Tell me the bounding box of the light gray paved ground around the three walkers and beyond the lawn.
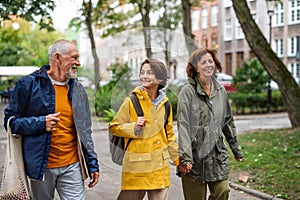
[0,103,291,200]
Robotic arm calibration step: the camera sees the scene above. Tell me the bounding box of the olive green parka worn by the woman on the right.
[177,77,243,182]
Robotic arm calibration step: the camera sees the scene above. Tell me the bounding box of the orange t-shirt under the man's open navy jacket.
[47,85,79,168]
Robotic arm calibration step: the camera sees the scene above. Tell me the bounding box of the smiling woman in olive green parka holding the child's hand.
[177,48,243,200]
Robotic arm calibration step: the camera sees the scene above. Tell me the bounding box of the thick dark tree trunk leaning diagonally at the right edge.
[232,0,300,128]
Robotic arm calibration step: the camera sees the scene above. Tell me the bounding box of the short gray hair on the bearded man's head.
[48,39,73,63]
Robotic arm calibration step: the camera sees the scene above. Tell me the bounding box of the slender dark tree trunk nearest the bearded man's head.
[85,0,100,89]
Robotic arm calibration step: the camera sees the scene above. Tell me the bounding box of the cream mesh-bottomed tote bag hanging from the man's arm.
[0,117,31,200]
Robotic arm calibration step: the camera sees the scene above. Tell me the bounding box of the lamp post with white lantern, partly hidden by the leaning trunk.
[266,0,276,113]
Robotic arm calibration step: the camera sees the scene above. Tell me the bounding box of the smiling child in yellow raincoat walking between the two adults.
[110,59,179,200]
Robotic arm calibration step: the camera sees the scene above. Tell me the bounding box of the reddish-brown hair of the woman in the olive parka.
[186,48,222,78]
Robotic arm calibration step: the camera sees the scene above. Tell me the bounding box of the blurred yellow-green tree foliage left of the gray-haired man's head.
[0,19,60,66]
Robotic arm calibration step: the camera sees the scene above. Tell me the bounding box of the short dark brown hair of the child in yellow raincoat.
[140,58,168,90]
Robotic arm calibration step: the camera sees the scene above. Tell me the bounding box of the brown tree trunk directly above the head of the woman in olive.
[181,0,198,54]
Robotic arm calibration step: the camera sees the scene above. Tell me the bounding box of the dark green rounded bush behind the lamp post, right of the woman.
[230,58,284,114]
